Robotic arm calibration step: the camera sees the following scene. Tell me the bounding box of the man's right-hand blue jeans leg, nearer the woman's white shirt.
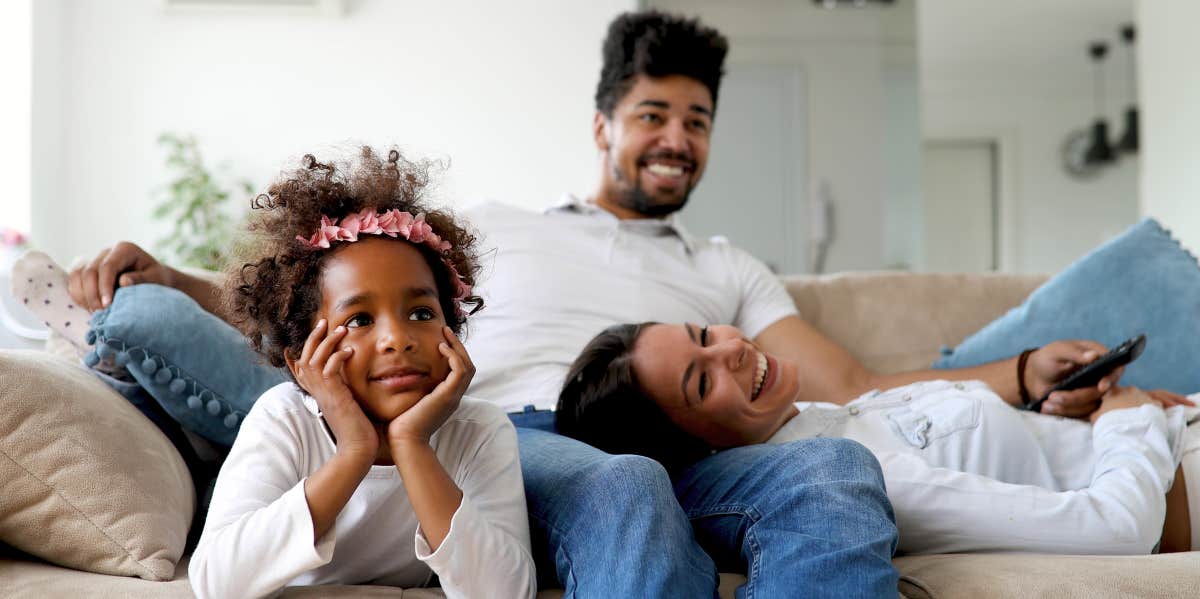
[676,439,899,599]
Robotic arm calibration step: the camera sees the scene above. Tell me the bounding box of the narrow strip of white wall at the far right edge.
[1138,0,1200,252]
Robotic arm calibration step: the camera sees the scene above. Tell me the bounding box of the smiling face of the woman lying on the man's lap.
[631,324,799,448]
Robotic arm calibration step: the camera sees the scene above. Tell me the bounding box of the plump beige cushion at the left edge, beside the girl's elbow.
[0,351,196,580]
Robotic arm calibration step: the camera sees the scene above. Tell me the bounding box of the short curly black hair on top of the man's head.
[595,11,730,118]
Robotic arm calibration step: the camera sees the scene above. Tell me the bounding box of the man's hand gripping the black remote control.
[1025,340,1124,418]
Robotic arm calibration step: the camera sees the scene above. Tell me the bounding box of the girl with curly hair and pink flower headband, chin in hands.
[188,149,535,598]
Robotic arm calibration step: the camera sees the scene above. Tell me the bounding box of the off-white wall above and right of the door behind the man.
[648,0,920,271]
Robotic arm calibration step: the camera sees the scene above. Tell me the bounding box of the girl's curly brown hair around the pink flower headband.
[224,146,484,367]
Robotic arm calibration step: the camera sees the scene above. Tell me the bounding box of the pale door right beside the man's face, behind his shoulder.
[680,64,808,274]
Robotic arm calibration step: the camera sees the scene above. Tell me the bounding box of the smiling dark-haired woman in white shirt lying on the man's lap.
[556,323,1200,553]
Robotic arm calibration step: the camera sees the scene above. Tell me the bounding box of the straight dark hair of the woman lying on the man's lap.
[554,323,713,474]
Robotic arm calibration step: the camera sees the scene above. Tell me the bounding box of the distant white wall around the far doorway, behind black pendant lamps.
[922,86,1139,272]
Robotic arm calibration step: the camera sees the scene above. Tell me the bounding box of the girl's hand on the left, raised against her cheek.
[288,319,379,461]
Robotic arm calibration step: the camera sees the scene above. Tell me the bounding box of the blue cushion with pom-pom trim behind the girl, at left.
[84,284,290,447]
